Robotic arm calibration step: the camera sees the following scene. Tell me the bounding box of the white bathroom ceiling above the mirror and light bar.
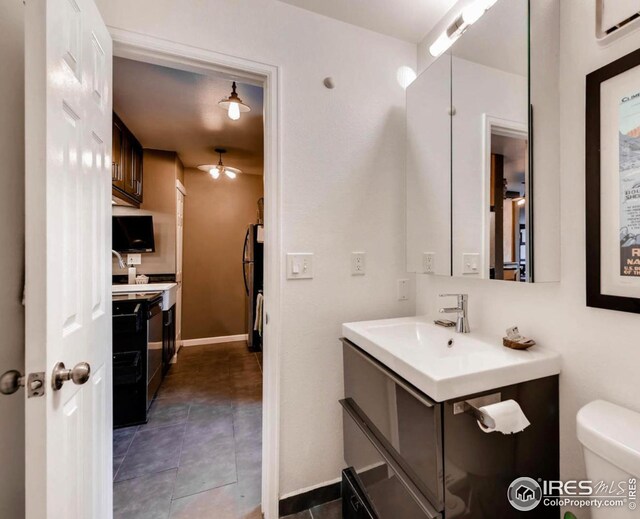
[280,0,456,43]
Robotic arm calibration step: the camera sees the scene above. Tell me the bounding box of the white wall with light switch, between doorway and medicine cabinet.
[98,0,416,494]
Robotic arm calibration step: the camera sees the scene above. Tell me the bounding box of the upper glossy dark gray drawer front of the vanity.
[343,339,444,511]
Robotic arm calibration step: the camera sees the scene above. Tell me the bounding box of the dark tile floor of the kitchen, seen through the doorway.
[113,342,264,519]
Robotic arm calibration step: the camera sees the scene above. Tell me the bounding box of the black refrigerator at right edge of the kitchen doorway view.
[242,224,264,351]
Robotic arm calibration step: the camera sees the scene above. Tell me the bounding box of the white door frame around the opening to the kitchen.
[107,25,282,519]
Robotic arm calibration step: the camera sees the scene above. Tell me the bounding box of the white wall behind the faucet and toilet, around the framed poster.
[417,0,640,508]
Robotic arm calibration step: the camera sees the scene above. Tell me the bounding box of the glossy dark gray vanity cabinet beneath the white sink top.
[340,339,560,519]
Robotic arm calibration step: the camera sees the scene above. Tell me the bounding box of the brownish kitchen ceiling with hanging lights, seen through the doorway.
[113,58,264,175]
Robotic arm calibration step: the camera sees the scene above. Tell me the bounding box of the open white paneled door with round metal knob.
[25,0,112,519]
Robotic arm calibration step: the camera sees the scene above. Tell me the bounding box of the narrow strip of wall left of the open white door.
[0,0,24,518]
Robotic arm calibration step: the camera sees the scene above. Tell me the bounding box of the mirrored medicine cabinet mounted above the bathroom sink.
[406,0,559,282]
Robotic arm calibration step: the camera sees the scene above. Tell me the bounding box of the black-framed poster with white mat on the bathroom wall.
[586,50,640,313]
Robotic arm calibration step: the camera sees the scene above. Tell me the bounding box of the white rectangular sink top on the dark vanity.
[342,317,560,402]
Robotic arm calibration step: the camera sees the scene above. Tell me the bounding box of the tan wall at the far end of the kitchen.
[182,168,263,339]
